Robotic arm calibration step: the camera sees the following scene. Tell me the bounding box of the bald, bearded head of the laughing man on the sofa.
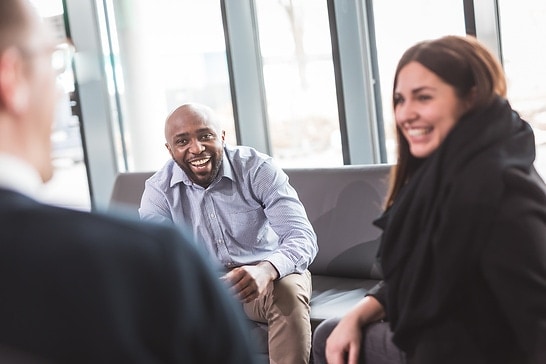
[165,104,225,188]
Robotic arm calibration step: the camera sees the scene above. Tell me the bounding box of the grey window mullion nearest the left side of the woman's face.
[329,0,382,164]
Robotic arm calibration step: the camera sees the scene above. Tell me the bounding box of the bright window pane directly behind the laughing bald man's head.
[107,0,236,171]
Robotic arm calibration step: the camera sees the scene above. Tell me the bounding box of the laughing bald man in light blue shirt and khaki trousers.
[139,104,317,364]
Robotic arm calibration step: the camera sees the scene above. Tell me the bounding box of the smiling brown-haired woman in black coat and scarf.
[313,36,546,364]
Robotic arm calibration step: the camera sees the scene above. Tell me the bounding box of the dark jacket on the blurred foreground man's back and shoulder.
[0,190,255,363]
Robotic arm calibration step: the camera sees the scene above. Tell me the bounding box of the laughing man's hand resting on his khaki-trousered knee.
[222,261,279,303]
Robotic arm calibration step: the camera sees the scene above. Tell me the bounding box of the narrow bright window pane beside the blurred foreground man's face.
[33,0,91,211]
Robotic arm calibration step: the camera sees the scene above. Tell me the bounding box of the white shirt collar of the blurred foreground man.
[0,153,43,198]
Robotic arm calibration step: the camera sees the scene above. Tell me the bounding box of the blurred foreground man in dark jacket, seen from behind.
[0,0,253,364]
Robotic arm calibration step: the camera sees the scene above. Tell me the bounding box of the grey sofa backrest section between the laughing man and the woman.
[285,164,391,279]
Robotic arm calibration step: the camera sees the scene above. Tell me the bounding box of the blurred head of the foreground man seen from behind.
[0,0,60,182]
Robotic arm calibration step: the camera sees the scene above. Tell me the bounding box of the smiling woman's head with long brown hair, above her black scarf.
[389,36,506,208]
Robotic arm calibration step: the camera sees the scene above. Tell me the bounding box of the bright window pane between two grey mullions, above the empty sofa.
[256,0,343,167]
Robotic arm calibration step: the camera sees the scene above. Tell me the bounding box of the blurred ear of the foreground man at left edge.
[0,47,29,114]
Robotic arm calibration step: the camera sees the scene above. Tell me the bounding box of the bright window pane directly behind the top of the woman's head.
[373,0,465,163]
